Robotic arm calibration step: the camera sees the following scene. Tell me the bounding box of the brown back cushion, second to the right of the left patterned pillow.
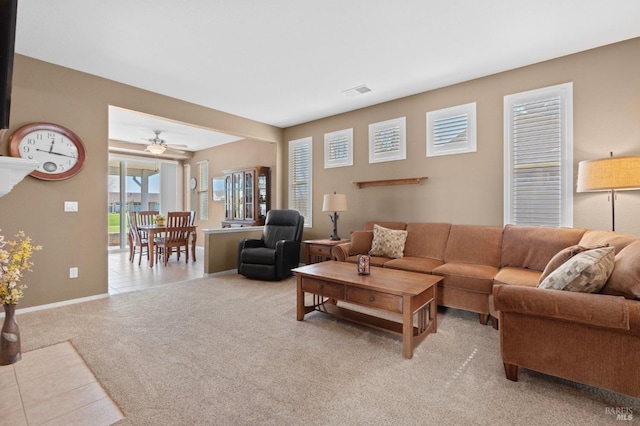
[444,225,502,266]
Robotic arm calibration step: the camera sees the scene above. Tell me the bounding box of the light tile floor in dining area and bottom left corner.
[0,247,204,426]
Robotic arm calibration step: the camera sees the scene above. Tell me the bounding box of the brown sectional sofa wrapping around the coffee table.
[332,221,640,398]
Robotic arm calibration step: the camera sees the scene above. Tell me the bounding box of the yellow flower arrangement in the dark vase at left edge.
[0,231,42,305]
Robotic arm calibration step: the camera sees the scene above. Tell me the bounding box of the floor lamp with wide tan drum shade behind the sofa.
[576,153,640,231]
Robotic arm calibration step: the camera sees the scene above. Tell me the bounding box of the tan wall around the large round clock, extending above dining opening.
[0,55,282,308]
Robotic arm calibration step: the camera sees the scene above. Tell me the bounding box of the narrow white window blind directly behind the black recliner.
[289,138,312,226]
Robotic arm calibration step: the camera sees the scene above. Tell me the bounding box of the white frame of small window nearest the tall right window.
[427,102,478,157]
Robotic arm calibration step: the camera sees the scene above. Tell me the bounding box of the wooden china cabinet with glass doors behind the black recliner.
[222,167,271,228]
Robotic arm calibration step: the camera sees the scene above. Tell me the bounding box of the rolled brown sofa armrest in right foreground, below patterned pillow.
[493,285,640,335]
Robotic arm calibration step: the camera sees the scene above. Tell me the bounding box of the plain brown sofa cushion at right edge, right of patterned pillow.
[602,241,640,300]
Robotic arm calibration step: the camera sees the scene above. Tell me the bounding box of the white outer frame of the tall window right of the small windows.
[503,82,574,228]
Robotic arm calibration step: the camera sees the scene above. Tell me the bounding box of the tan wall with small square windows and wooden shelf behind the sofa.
[281,38,640,238]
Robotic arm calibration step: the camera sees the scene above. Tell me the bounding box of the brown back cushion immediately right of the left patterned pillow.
[404,223,451,260]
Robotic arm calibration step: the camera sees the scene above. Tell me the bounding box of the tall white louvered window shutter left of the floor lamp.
[505,84,573,227]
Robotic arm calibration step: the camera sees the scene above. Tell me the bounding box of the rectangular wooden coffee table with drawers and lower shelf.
[293,261,442,358]
